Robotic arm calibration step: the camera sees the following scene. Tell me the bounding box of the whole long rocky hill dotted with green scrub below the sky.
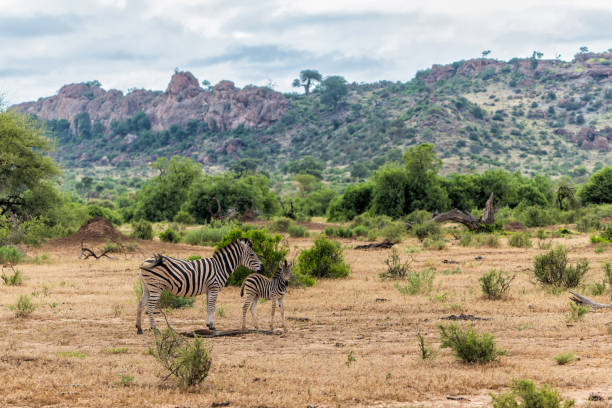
[12,53,612,177]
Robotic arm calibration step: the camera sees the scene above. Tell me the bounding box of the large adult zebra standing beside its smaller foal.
[136,239,264,334]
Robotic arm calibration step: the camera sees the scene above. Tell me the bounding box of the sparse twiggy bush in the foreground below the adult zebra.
[149,329,212,387]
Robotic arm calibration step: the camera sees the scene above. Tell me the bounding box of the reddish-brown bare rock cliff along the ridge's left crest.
[11,72,289,131]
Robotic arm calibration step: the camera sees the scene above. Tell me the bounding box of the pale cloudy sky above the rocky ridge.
[0,0,612,105]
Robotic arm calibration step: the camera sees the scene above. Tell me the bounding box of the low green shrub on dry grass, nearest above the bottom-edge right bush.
[439,324,506,364]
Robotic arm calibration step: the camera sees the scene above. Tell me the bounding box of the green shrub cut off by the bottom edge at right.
[490,380,574,408]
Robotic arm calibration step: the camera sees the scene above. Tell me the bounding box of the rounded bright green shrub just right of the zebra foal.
[295,236,351,278]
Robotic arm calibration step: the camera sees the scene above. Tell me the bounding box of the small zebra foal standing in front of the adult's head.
[240,260,293,331]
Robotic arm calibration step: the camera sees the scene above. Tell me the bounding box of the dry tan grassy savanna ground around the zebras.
[0,225,612,407]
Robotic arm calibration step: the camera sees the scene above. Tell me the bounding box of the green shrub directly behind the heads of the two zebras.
[216,228,289,286]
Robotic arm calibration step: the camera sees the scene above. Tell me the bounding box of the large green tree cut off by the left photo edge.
[0,112,60,220]
